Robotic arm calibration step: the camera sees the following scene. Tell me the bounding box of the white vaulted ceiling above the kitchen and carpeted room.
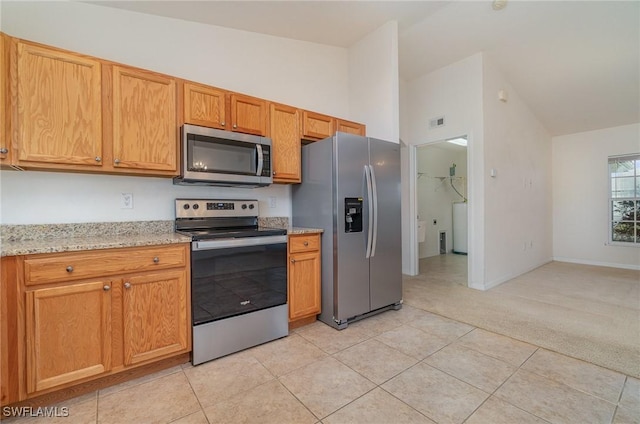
[88,0,640,135]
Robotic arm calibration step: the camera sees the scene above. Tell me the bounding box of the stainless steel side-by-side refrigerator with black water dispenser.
[292,132,402,329]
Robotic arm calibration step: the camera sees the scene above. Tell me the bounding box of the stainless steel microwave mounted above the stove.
[173,124,273,187]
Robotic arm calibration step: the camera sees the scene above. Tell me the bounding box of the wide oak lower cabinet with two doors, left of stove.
[0,244,191,405]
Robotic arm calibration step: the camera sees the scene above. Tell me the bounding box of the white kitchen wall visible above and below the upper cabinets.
[0,1,352,224]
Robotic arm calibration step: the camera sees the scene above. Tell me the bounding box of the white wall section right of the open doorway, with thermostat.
[483,56,552,288]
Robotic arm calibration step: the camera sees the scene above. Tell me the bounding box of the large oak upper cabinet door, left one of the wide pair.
[16,42,102,169]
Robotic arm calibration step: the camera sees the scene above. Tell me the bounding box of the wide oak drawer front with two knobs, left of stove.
[24,245,187,285]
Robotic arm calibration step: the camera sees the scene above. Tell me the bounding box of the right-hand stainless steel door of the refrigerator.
[369,139,402,310]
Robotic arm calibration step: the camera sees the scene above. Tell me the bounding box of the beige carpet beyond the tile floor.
[404,255,640,378]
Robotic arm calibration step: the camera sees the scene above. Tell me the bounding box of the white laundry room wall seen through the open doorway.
[416,143,467,258]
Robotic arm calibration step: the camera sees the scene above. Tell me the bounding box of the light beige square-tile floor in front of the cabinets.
[2,305,640,424]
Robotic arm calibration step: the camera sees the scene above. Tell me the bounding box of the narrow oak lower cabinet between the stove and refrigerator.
[287,234,321,328]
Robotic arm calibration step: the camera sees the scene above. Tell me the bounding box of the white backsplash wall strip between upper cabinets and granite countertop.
[0,171,291,224]
